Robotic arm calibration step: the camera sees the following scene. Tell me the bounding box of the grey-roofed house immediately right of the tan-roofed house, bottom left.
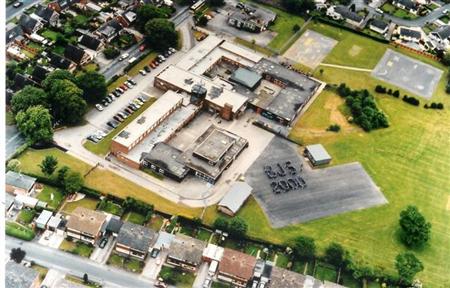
[115,222,157,260]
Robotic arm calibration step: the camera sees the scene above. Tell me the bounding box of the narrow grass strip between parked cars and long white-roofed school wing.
[83,98,156,156]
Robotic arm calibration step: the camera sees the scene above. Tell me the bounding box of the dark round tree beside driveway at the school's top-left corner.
[144,18,178,51]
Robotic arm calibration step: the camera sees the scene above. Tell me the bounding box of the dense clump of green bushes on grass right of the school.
[337,83,389,131]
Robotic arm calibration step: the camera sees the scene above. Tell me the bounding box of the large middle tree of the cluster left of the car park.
[49,80,87,124]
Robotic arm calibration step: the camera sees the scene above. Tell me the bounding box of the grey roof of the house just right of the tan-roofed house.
[117,222,157,252]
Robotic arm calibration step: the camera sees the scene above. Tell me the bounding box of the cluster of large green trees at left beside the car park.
[11,70,107,144]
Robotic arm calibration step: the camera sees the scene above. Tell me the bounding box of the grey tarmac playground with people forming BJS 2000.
[245,138,387,228]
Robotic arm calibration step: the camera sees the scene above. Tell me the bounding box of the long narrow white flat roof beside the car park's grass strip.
[113,90,183,147]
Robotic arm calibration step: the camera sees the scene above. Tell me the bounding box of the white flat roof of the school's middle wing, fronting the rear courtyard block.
[157,65,248,113]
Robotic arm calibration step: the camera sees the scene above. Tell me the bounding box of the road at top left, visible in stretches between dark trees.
[99,7,191,80]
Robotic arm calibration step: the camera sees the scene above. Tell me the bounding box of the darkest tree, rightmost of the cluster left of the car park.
[77,71,108,103]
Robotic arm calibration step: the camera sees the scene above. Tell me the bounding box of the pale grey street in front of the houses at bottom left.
[5,236,154,288]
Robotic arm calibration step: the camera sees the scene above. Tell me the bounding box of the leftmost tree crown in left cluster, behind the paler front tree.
[11,85,50,114]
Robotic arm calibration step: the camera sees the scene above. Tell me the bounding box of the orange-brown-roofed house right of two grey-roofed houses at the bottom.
[217,248,256,287]
